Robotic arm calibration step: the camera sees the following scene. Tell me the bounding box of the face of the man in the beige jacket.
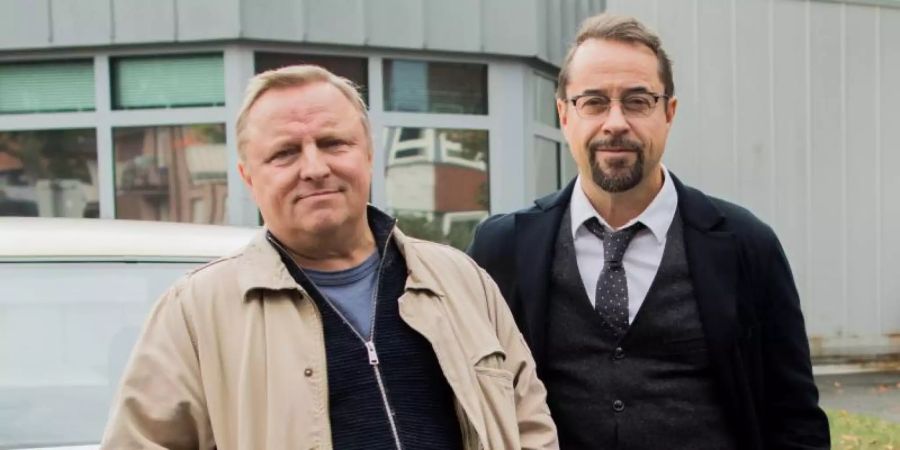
[238,82,372,243]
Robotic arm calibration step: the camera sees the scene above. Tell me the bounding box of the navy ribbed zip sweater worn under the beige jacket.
[273,207,462,450]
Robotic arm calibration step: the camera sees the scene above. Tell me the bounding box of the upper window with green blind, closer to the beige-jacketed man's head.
[110,54,225,109]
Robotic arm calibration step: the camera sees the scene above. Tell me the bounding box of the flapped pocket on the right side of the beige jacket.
[474,351,520,449]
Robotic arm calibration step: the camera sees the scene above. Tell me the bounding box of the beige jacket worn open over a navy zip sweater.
[101,228,558,450]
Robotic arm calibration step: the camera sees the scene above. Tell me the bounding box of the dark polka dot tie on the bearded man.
[584,217,644,334]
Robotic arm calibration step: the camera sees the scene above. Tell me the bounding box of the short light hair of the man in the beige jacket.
[237,64,369,159]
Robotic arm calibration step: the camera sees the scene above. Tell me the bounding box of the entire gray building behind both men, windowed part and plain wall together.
[0,0,900,356]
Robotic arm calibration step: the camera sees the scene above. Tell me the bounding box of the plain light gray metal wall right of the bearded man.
[609,0,900,348]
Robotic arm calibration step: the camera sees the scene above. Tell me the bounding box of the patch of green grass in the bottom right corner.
[825,410,900,450]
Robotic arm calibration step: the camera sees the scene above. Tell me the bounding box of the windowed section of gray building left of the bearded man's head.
[0,0,604,247]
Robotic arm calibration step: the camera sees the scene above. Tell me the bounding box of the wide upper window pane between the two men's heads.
[383,59,488,114]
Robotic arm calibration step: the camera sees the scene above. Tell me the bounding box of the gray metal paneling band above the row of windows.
[0,0,605,64]
